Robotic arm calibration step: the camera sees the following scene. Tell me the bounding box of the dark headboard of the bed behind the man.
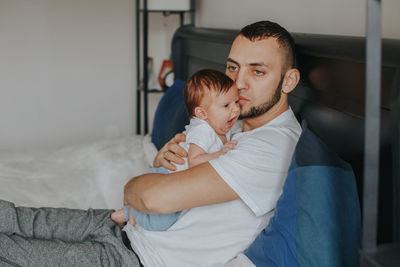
[172,26,400,245]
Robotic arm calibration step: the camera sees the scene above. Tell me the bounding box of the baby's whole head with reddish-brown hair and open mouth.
[183,69,240,135]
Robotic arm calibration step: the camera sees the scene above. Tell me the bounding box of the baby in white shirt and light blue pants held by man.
[111,69,240,231]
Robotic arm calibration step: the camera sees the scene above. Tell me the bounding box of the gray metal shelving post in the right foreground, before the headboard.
[360,0,400,267]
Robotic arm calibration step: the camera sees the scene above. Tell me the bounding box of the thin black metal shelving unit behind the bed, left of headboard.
[136,0,195,134]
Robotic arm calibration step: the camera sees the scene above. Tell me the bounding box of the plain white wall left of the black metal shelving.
[0,0,136,151]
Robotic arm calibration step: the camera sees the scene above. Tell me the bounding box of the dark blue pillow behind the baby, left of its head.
[151,80,189,150]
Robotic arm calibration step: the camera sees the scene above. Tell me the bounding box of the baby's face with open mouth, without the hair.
[203,85,240,135]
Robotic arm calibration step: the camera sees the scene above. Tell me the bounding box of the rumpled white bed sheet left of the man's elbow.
[0,136,157,209]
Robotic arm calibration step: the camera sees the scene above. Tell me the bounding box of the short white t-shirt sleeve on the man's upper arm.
[210,128,298,216]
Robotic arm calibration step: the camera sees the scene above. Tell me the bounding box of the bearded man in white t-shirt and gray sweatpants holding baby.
[0,21,301,266]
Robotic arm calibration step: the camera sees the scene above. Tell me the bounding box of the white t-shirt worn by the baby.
[174,117,231,172]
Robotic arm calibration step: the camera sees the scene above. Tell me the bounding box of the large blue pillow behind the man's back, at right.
[245,122,361,267]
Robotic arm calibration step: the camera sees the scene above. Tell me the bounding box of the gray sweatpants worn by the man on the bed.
[0,200,139,266]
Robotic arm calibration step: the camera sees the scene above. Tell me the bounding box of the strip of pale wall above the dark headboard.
[196,0,400,39]
